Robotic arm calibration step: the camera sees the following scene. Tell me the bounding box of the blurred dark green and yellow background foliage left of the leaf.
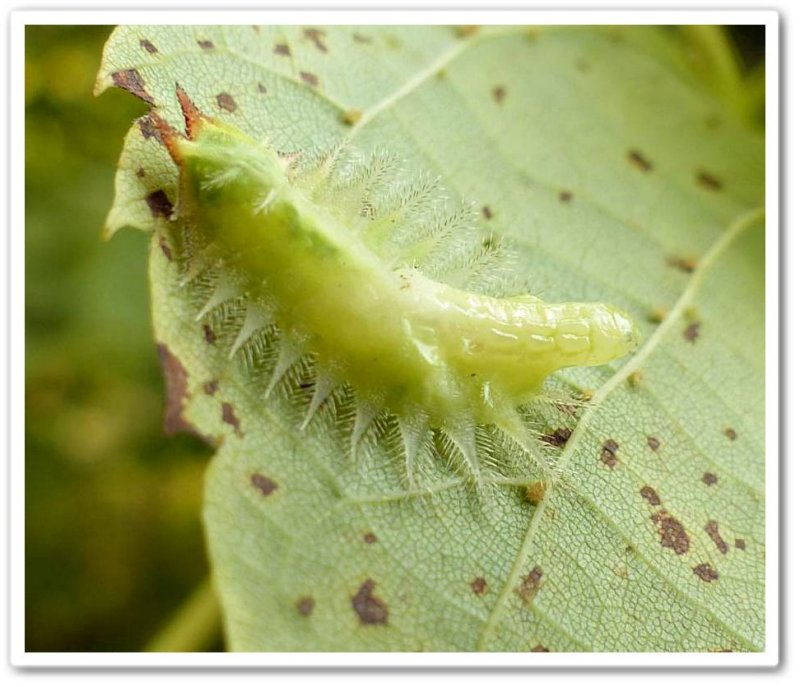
[25,26,210,651]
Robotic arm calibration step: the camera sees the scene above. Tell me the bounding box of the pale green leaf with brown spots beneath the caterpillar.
[98,26,765,651]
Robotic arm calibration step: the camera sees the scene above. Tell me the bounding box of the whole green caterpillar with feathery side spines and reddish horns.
[151,88,638,482]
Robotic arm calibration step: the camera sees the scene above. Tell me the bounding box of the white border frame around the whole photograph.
[8,10,780,669]
